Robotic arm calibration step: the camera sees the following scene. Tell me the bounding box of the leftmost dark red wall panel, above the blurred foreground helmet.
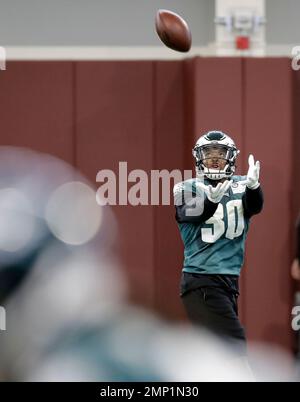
[0,62,74,163]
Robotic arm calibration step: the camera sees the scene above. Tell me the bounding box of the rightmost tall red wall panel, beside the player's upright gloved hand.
[244,58,293,346]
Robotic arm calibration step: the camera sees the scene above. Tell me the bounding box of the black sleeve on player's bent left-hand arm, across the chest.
[175,197,218,223]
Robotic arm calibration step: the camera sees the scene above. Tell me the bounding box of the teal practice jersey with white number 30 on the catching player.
[174,176,250,275]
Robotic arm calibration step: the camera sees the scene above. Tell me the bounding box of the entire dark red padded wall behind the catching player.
[0,57,300,347]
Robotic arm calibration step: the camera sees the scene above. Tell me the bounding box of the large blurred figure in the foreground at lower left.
[0,148,296,381]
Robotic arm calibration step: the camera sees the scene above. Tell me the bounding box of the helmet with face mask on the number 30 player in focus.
[192,130,240,180]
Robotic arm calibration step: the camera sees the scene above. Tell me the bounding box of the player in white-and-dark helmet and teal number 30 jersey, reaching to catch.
[174,131,263,354]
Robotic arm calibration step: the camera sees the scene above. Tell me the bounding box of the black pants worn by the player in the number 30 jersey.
[181,273,246,354]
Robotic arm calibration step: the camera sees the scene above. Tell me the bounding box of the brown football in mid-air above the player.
[155,10,192,52]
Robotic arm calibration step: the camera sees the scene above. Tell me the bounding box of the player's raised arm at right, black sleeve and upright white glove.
[242,155,264,218]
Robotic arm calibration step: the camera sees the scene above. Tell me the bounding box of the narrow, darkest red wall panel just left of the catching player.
[153,61,185,318]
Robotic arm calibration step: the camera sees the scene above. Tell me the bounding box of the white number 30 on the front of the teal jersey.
[201,200,245,243]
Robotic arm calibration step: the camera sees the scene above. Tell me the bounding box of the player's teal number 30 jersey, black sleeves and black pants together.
[174,176,263,349]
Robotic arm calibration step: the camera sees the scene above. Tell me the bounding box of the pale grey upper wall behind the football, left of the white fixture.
[0,0,214,46]
